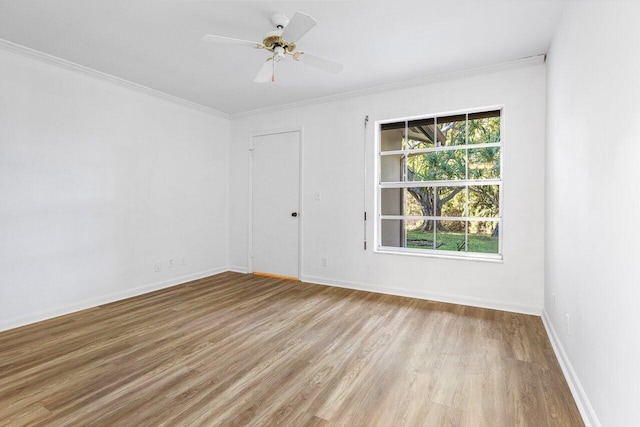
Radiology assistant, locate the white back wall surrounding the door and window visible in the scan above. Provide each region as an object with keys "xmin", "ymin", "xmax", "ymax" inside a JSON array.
[{"xmin": 230, "ymin": 62, "xmax": 545, "ymax": 314}]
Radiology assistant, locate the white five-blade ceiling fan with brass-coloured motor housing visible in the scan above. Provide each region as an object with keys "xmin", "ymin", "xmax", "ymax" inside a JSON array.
[{"xmin": 203, "ymin": 12, "xmax": 342, "ymax": 83}]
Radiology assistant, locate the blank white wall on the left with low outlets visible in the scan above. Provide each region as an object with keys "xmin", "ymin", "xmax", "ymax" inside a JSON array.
[{"xmin": 0, "ymin": 49, "xmax": 229, "ymax": 330}]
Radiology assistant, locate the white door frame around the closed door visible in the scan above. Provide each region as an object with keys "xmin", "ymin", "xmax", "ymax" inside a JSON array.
[{"xmin": 247, "ymin": 126, "xmax": 304, "ymax": 279}]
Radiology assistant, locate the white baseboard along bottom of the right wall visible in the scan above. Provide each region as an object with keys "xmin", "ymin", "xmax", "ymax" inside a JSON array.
[{"xmin": 542, "ymin": 310, "xmax": 601, "ymax": 427}]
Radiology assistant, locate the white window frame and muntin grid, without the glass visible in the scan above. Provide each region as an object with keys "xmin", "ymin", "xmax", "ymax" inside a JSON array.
[{"xmin": 374, "ymin": 105, "xmax": 505, "ymax": 262}]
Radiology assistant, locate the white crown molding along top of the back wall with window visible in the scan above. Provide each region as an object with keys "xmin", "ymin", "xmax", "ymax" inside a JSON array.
[{"xmin": 229, "ymin": 54, "xmax": 546, "ymax": 119}]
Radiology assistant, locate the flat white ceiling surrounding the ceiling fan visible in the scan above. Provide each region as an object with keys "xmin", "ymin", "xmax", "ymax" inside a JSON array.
[{"xmin": 0, "ymin": 0, "xmax": 563, "ymax": 114}]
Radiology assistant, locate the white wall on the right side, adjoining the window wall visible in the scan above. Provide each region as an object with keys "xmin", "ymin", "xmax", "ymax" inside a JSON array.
[{"xmin": 544, "ymin": 1, "xmax": 640, "ymax": 427}]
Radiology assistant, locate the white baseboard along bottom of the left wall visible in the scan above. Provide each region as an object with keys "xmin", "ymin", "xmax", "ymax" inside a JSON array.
[{"xmin": 0, "ymin": 266, "xmax": 229, "ymax": 332}]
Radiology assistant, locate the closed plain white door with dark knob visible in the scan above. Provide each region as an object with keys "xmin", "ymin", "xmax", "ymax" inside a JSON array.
[{"xmin": 250, "ymin": 131, "xmax": 300, "ymax": 278}]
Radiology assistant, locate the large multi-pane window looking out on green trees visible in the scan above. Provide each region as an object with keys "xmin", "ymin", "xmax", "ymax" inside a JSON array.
[{"xmin": 376, "ymin": 109, "xmax": 503, "ymax": 259}]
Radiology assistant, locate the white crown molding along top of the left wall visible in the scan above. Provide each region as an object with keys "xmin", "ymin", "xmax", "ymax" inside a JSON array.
[{"xmin": 0, "ymin": 39, "xmax": 230, "ymax": 119}]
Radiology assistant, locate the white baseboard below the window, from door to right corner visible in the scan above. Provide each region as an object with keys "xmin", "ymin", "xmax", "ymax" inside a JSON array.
[{"xmin": 300, "ymin": 276, "xmax": 542, "ymax": 316}]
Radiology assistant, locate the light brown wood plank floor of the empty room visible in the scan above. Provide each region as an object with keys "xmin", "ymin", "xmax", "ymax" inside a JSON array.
[{"xmin": 0, "ymin": 273, "xmax": 583, "ymax": 427}]
